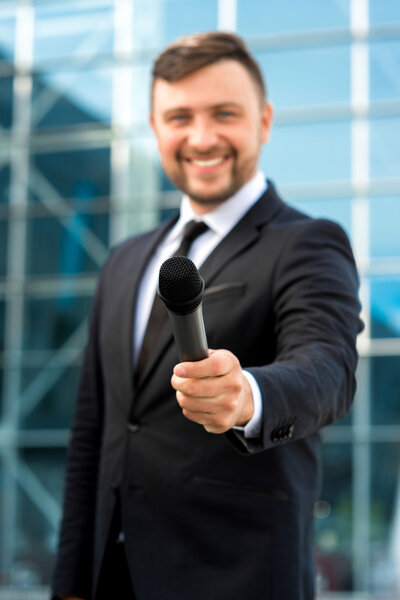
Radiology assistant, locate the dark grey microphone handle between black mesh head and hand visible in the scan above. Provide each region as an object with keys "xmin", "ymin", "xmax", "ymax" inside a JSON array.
[{"xmin": 167, "ymin": 303, "xmax": 208, "ymax": 362}]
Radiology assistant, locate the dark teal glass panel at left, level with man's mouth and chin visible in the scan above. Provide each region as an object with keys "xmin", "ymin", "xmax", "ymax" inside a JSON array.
[{"xmin": 29, "ymin": 148, "xmax": 110, "ymax": 203}]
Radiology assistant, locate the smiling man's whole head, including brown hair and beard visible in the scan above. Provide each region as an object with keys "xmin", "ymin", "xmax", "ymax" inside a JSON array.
[{"xmin": 151, "ymin": 32, "xmax": 272, "ymax": 212}]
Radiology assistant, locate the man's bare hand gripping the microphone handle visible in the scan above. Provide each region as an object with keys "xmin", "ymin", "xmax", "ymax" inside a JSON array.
[{"xmin": 171, "ymin": 350, "xmax": 254, "ymax": 433}]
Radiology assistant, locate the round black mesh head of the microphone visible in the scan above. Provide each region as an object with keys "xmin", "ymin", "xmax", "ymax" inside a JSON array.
[{"xmin": 158, "ymin": 256, "xmax": 204, "ymax": 315}]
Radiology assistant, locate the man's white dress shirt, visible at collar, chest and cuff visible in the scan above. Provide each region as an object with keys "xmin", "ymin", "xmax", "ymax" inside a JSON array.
[{"xmin": 133, "ymin": 171, "xmax": 267, "ymax": 438}]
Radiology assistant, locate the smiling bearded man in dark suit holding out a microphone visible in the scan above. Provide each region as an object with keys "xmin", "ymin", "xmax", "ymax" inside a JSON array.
[{"xmin": 53, "ymin": 33, "xmax": 361, "ymax": 600}]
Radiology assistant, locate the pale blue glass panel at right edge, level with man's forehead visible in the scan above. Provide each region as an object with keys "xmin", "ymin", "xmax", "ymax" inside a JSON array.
[{"xmin": 370, "ymin": 41, "xmax": 400, "ymax": 100}]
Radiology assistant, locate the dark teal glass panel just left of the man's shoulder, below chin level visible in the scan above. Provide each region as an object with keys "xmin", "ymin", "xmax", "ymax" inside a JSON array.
[{"xmin": 26, "ymin": 212, "xmax": 109, "ymax": 275}]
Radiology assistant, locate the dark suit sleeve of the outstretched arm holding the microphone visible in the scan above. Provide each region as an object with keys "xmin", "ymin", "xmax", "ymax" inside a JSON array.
[{"xmin": 229, "ymin": 220, "xmax": 362, "ymax": 452}]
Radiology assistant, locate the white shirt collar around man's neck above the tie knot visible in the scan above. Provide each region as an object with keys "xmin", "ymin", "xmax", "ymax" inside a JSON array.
[{"xmin": 171, "ymin": 171, "xmax": 268, "ymax": 238}]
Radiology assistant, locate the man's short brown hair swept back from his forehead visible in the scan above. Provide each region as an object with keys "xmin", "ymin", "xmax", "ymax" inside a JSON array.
[{"xmin": 151, "ymin": 31, "xmax": 266, "ymax": 101}]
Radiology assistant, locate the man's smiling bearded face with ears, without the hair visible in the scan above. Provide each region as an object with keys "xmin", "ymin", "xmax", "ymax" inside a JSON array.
[{"xmin": 150, "ymin": 60, "xmax": 272, "ymax": 214}]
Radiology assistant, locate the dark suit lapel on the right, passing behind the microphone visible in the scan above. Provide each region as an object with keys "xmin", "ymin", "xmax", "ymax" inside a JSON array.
[{"xmin": 137, "ymin": 182, "xmax": 283, "ymax": 392}]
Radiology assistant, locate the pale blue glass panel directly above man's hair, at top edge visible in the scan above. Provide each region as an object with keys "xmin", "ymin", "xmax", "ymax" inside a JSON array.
[{"xmin": 133, "ymin": 0, "xmax": 218, "ymax": 49}]
